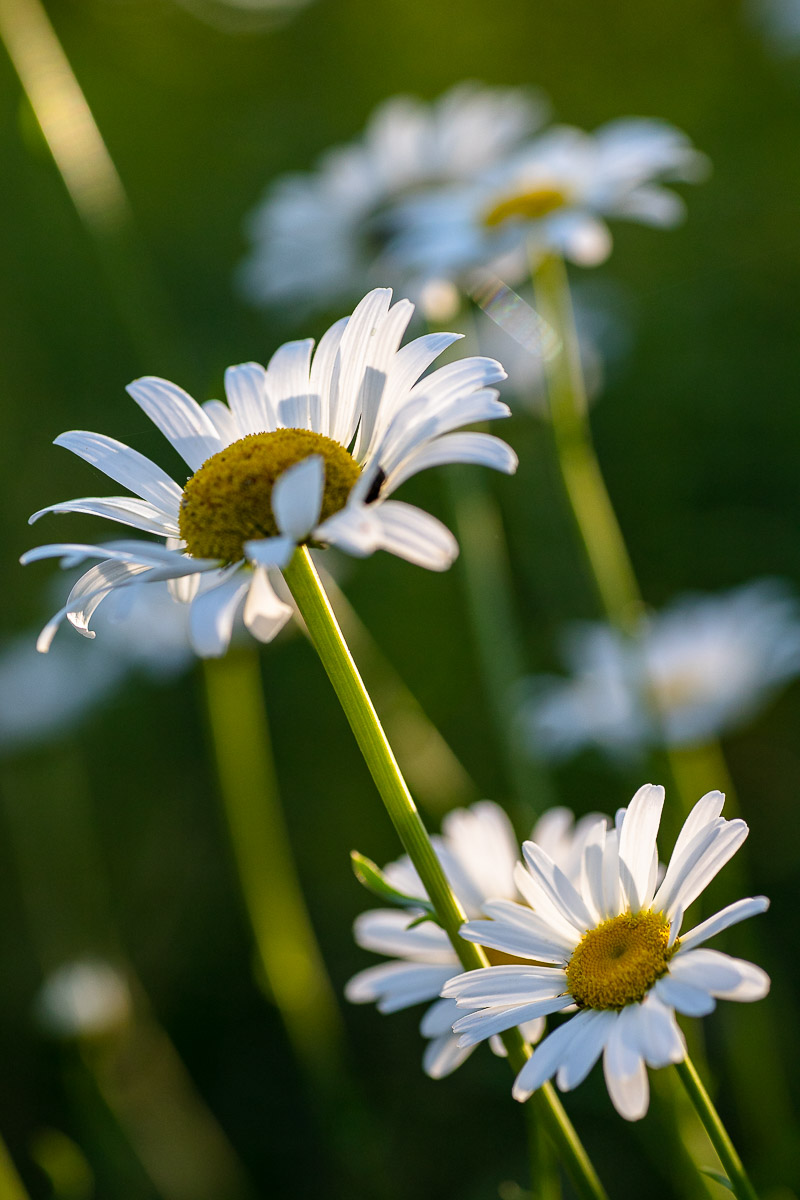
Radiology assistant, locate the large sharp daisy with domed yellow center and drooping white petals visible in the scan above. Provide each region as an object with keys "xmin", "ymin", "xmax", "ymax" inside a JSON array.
[{"xmin": 22, "ymin": 288, "xmax": 517, "ymax": 656}]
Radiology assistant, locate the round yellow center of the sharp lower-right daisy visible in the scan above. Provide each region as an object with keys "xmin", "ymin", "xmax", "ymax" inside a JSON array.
[{"xmin": 566, "ymin": 912, "xmax": 680, "ymax": 1008}]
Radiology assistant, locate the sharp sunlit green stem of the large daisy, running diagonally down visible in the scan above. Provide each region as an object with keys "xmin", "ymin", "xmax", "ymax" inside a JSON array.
[{"xmin": 283, "ymin": 546, "xmax": 606, "ymax": 1200}]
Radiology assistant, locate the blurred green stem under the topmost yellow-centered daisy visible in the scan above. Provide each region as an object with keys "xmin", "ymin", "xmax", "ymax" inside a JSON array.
[{"xmin": 533, "ymin": 254, "xmax": 643, "ymax": 632}]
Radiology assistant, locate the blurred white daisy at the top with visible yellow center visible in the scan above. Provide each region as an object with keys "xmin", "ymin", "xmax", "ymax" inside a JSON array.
[{"xmin": 389, "ymin": 118, "xmax": 708, "ymax": 287}]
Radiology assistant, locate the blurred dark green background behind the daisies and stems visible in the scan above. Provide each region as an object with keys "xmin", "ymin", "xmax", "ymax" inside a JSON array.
[{"xmin": 0, "ymin": 0, "xmax": 800, "ymax": 1200}]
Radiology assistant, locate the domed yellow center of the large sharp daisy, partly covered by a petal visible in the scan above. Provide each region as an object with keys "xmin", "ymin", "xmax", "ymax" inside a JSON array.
[{"xmin": 179, "ymin": 430, "xmax": 361, "ymax": 563}]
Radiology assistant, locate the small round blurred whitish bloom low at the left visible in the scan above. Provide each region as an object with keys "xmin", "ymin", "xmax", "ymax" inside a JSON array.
[{"xmin": 36, "ymin": 959, "xmax": 133, "ymax": 1038}]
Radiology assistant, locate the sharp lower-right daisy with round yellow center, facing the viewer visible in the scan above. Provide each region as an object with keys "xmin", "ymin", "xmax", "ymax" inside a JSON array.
[{"xmin": 443, "ymin": 784, "xmax": 769, "ymax": 1121}]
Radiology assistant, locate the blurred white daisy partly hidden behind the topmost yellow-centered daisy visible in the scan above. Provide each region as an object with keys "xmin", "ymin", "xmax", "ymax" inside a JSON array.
[{"xmin": 241, "ymin": 83, "xmax": 546, "ymax": 312}]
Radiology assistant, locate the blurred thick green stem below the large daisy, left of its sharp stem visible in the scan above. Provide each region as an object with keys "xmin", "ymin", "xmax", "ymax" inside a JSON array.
[{"xmin": 204, "ymin": 648, "xmax": 342, "ymax": 1079}]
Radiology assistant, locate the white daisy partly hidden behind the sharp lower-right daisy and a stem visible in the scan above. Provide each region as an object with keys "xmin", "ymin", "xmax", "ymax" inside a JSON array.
[{"xmin": 345, "ymin": 800, "xmax": 604, "ymax": 1079}]
